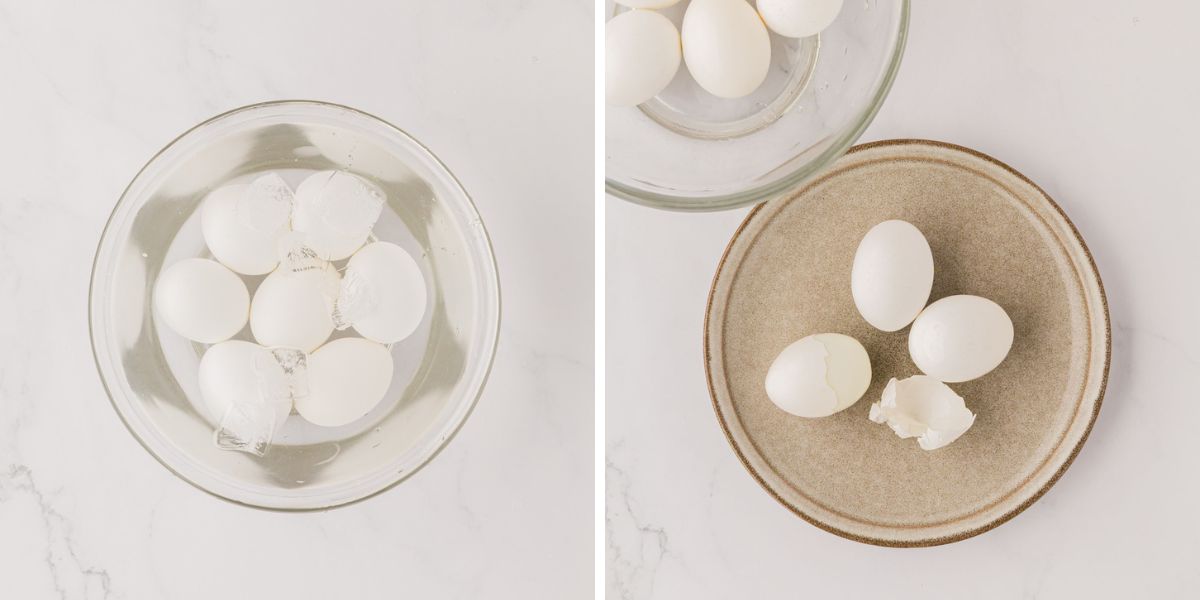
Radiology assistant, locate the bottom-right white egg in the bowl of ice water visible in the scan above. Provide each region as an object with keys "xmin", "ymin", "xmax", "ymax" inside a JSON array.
[{"xmin": 296, "ymin": 337, "xmax": 392, "ymax": 427}]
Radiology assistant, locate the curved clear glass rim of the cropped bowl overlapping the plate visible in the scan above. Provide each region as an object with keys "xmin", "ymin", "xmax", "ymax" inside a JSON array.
[{"xmin": 604, "ymin": 0, "xmax": 911, "ymax": 212}]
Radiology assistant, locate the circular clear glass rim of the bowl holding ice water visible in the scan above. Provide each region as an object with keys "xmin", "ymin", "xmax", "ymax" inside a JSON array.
[{"xmin": 88, "ymin": 100, "xmax": 502, "ymax": 512}]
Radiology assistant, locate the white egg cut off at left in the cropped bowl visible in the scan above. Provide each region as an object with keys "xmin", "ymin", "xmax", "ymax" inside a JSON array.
[{"xmin": 604, "ymin": 11, "xmax": 683, "ymax": 107}]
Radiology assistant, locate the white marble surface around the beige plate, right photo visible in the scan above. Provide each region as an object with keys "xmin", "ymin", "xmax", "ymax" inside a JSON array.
[{"xmin": 606, "ymin": 0, "xmax": 1200, "ymax": 600}]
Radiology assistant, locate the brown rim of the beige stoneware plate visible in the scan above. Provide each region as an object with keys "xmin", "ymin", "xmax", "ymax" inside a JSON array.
[{"xmin": 704, "ymin": 138, "xmax": 1112, "ymax": 548}]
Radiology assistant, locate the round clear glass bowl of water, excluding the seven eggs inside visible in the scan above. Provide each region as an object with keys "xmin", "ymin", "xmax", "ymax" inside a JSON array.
[{"xmin": 89, "ymin": 101, "xmax": 499, "ymax": 510}]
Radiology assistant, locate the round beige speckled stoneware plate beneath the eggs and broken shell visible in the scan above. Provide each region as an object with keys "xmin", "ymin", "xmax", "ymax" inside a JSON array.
[{"xmin": 704, "ymin": 140, "xmax": 1110, "ymax": 546}]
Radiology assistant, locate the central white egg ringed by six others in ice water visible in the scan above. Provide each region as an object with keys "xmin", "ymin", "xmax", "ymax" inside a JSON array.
[{"xmin": 250, "ymin": 263, "xmax": 341, "ymax": 352}]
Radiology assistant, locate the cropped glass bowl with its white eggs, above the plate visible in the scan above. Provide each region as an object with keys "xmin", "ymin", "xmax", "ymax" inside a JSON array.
[{"xmin": 605, "ymin": 0, "xmax": 910, "ymax": 211}]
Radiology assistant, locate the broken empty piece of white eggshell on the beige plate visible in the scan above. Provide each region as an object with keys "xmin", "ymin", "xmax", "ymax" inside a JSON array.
[{"xmin": 870, "ymin": 376, "xmax": 974, "ymax": 450}]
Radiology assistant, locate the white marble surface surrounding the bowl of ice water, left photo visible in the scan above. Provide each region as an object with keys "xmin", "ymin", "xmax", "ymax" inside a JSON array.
[{"xmin": 0, "ymin": 0, "xmax": 594, "ymax": 600}]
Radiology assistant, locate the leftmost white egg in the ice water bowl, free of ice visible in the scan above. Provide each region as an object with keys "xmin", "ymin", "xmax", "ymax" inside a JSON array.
[{"xmin": 154, "ymin": 258, "xmax": 250, "ymax": 343}]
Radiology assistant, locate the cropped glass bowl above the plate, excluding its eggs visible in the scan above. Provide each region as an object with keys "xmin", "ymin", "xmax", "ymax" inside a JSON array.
[{"xmin": 605, "ymin": 0, "xmax": 908, "ymax": 211}]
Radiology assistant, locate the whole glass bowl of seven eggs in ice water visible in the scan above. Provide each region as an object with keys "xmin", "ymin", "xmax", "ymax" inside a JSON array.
[{"xmin": 89, "ymin": 101, "xmax": 499, "ymax": 510}]
